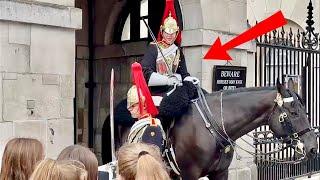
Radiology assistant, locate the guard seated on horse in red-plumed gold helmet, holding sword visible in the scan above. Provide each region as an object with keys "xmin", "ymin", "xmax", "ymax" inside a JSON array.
[{"xmin": 141, "ymin": 0, "xmax": 200, "ymax": 117}]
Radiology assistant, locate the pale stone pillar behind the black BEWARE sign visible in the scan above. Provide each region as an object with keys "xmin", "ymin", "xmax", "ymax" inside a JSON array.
[{"xmin": 180, "ymin": 0, "xmax": 256, "ymax": 180}]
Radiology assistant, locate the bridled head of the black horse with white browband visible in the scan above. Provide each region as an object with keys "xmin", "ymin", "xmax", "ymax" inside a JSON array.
[{"xmin": 269, "ymin": 80, "xmax": 318, "ymax": 158}]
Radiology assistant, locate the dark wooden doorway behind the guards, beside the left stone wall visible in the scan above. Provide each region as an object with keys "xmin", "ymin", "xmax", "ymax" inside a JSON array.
[{"xmin": 75, "ymin": 0, "xmax": 171, "ymax": 163}]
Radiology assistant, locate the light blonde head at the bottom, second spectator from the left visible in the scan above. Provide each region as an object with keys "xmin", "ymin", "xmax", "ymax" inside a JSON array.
[{"xmin": 30, "ymin": 159, "xmax": 88, "ymax": 180}]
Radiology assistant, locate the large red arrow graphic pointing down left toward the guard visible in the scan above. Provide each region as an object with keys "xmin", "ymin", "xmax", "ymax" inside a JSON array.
[{"xmin": 204, "ymin": 11, "xmax": 287, "ymax": 60}]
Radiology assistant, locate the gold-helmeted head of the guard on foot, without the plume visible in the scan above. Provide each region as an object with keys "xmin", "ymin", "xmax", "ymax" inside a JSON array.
[{"xmin": 127, "ymin": 85, "xmax": 147, "ymax": 118}]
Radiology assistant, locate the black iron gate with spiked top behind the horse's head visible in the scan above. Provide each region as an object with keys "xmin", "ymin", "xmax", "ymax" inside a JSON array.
[{"xmin": 254, "ymin": 2, "xmax": 320, "ymax": 180}]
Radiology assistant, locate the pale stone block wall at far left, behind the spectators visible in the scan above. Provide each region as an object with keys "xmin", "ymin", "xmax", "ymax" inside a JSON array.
[{"xmin": 0, "ymin": 0, "xmax": 82, "ymax": 158}]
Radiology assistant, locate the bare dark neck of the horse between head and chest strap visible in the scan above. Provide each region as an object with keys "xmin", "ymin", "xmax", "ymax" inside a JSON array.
[{"xmin": 223, "ymin": 89, "xmax": 276, "ymax": 140}]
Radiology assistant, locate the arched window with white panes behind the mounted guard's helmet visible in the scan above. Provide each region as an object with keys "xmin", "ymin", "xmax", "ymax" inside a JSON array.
[{"xmin": 113, "ymin": 0, "xmax": 170, "ymax": 43}]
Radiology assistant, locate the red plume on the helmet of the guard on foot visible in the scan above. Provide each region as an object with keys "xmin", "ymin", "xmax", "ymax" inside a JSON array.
[{"xmin": 131, "ymin": 62, "xmax": 158, "ymax": 117}]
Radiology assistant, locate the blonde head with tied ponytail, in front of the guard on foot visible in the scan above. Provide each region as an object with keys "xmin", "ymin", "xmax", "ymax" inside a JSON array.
[{"xmin": 118, "ymin": 143, "xmax": 170, "ymax": 180}]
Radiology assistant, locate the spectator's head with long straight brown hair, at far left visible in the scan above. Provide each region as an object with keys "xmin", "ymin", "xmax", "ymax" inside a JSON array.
[{"xmin": 0, "ymin": 138, "xmax": 44, "ymax": 180}]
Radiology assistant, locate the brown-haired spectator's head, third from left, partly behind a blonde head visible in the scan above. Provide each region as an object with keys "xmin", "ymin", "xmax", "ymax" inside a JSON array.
[{"xmin": 58, "ymin": 145, "xmax": 98, "ymax": 180}]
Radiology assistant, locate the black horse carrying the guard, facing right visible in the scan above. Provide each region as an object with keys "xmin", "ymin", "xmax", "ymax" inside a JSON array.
[{"xmin": 102, "ymin": 82, "xmax": 318, "ymax": 180}]
